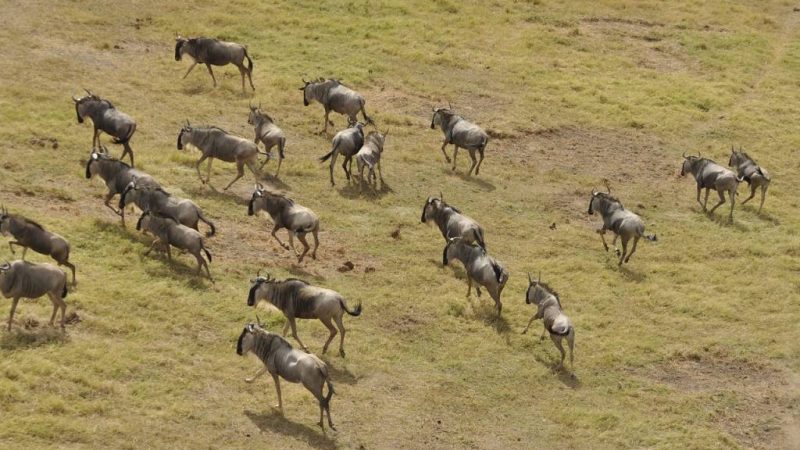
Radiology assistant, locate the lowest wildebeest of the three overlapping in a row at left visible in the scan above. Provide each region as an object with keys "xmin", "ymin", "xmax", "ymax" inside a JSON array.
[{"xmin": 136, "ymin": 211, "xmax": 212, "ymax": 280}]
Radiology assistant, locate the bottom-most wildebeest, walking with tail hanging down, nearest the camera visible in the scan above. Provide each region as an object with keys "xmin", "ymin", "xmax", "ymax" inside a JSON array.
[{"xmin": 236, "ymin": 323, "xmax": 336, "ymax": 430}]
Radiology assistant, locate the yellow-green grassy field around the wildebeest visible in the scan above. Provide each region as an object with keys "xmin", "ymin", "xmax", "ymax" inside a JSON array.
[{"xmin": 0, "ymin": 0, "xmax": 800, "ymax": 448}]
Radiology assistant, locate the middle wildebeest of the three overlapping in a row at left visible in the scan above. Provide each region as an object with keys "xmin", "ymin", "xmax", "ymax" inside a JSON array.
[{"xmin": 119, "ymin": 179, "xmax": 216, "ymax": 237}]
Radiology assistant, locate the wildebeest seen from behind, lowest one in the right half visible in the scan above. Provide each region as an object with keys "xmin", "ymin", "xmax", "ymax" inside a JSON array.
[{"xmin": 522, "ymin": 273, "xmax": 575, "ymax": 367}]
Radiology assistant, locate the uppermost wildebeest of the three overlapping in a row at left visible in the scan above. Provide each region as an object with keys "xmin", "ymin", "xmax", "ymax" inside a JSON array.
[{"xmin": 86, "ymin": 148, "xmax": 160, "ymax": 226}]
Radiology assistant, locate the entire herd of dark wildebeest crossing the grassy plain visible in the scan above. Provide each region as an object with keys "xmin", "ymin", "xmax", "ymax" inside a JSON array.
[{"xmin": 0, "ymin": 36, "xmax": 771, "ymax": 429}]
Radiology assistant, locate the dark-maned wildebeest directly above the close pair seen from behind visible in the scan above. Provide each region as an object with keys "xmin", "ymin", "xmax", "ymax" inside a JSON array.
[{"xmin": 300, "ymin": 78, "xmax": 373, "ymax": 133}]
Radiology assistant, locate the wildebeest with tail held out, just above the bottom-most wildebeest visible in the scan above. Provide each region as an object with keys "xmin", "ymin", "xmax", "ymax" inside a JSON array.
[{"xmin": 247, "ymin": 274, "xmax": 361, "ymax": 357}]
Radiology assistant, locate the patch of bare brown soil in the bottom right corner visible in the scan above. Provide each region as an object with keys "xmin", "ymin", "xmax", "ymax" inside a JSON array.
[{"xmin": 645, "ymin": 356, "xmax": 800, "ymax": 448}]
